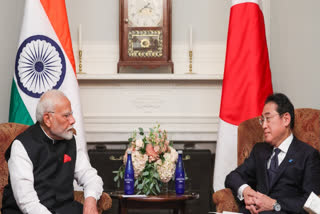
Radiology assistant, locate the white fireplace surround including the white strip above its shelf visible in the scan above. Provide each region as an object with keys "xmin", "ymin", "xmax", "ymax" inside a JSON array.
[{"xmin": 75, "ymin": 42, "xmax": 225, "ymax": 143}]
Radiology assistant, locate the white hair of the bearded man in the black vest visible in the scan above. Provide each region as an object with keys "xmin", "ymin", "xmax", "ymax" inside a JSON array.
[{"xmin": 36, "ymin": 89, "xmax": 66, "ymax": 123}]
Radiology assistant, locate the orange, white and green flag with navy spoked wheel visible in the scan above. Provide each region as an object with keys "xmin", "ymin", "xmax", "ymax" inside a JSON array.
[{"xmin": 9, "ymin": 0, "xmax": 86, "ymax": 149}]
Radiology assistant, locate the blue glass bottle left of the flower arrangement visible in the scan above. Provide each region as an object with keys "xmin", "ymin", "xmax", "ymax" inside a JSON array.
[{"xmin": 124, "ymin": 151, "xmax": 134, "ymax": 195}]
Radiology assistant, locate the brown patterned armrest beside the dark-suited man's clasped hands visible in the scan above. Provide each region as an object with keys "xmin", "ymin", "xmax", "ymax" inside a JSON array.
[{"xmin": 212, "ymin": 188, "xmax": 239, "ymax": 213}]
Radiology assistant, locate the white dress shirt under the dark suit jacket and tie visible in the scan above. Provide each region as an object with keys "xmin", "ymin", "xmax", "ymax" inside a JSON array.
[{"xmin": 238, "ymin": 133, "xmax": 293, "ymax": 201}]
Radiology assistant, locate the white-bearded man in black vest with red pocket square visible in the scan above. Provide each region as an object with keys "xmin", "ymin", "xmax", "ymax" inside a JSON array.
[{"xmin": 1, "ymin": 90, "xmax": 103, "ymax": 214}]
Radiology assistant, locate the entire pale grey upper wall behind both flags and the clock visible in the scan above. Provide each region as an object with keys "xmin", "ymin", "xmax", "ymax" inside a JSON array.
[{"xmin": 0, "ymin": 0, "xmax": 320, "ymax": 122}]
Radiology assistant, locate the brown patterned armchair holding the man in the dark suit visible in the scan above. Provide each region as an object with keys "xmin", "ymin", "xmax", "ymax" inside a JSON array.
[{"xmin": 212, "ymin": 108, "xmax": 320, "ymax": 212}]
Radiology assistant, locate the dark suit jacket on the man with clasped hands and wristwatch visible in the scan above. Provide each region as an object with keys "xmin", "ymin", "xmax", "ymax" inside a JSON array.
[{"xmin": 225, "ymin": 137, "xmax": 320, "ymax": 213}]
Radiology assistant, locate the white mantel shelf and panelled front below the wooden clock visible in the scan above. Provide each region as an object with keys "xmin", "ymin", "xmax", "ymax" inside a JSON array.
[{"xmin": 79, "ymin": 75, "xmax": 222, "ymax": 142}]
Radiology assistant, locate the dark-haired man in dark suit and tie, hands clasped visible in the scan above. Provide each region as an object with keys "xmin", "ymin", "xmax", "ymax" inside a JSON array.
[{"xmin": 225, "ymin": 93, "xmax": 320, "ymax": 214}]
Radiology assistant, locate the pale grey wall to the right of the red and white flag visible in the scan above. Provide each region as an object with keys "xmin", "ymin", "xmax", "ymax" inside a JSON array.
[{"xmin": 270, "ymin": 0, "xmax": 320, "ymax": 109}]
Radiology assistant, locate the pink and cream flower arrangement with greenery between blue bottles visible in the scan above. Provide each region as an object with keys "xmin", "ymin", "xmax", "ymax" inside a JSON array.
[{"xmin": 113, "ymin": 125, "xmax": 178, "ymax": 195}]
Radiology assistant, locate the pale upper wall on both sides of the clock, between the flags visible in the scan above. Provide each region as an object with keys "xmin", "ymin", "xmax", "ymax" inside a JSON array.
[{"xmin": 66, "ymin": 0, "xmax": 229, "ymax": 43}]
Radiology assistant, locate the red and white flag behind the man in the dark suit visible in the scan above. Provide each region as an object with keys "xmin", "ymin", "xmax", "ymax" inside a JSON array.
[{"xmin": 214, "ymin": 0, "xmax": 272, "ymax": 191}]
